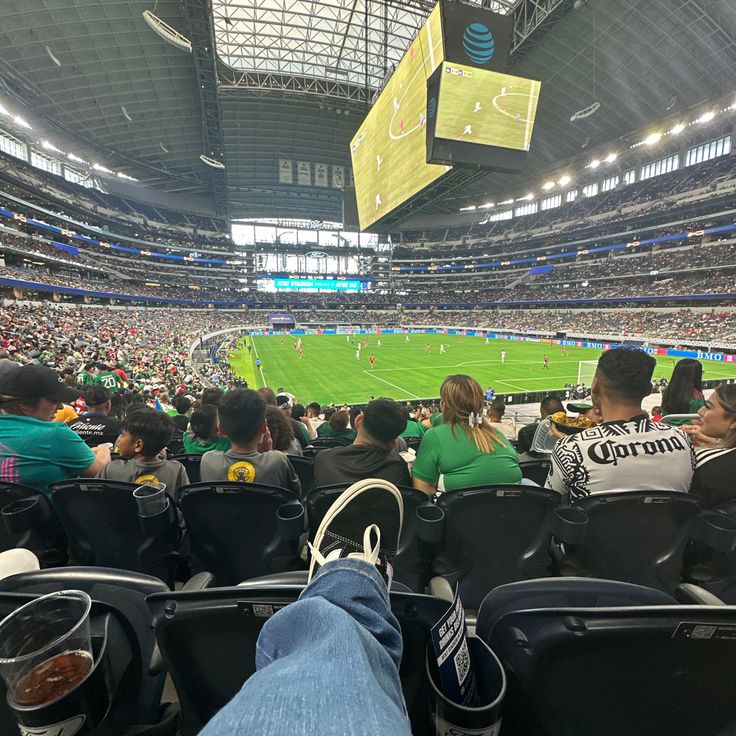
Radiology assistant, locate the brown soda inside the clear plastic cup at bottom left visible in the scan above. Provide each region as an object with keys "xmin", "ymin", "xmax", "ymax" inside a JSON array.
[{"xmin": 13, "ymin": 649, "xmax": 94, "ymax": 706}]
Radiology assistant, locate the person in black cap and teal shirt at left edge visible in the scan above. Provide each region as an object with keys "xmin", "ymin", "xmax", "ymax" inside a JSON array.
[{"xmin": 0, "ymin": 365, "xmax": 110, "ymax": 492}]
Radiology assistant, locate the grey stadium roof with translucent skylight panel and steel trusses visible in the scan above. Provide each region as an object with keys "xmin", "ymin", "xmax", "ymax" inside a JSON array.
[{"xmin": 0, "ymin": 0, "xmax": 736, "ymax": 224}]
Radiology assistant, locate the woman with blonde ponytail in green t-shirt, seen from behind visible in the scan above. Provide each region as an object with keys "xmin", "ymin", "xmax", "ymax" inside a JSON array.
[{"xmin": 412, "ymin": 374, "xmax": 521, "ymax": 498}]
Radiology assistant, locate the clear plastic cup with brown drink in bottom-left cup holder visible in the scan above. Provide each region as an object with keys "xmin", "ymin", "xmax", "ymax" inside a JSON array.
[{"xmin": 0, "ymin": 590, "xmax": 94, "ymax": 706}]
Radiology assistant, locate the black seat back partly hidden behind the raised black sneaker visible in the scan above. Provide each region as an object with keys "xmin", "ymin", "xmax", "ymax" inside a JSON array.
[{"xmin": 307, "ymin": 483, "xmax": 430, "ymax": 592}]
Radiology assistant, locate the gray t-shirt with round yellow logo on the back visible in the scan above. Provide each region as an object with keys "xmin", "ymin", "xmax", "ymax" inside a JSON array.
[{"xmin": 199, "ymin": 450, "xmax": 301, "ymax": 495}]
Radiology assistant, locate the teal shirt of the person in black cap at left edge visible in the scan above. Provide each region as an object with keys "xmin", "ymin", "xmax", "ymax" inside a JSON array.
[{"xmin": 0, "ymin": 414, "xmax": 95, "ymax": 495}]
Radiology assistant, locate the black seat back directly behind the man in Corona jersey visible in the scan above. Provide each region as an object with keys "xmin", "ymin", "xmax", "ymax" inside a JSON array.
[{"xmin": 561, "ymin": 491, "xmax": 699, "ymax": 593}]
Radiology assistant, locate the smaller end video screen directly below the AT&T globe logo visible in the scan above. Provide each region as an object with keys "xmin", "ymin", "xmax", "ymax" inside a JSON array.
[{"xmin": 434, "ymin": 62, "xmax": 541, "ymax": 151}]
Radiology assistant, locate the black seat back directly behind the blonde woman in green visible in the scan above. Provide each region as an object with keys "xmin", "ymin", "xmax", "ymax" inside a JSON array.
[{"xmin": 433, "ymin": 485, "xmax": 560, "ymax": 608}]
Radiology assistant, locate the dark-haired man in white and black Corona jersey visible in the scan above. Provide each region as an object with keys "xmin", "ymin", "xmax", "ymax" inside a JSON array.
[{"xmin": 546, "ymin": 348, "xmax": 695, "ymax": 501}]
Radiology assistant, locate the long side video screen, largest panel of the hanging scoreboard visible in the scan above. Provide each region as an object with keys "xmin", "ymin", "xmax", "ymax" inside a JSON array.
[{"xmin": 350, "ymin": 5, "xmax": 447, "ymax": 230}]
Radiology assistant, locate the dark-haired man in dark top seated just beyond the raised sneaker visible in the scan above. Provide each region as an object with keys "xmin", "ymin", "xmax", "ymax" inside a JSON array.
[{"xmin": 314, "ymin": 399, "xmax": 411, "ymax": 488}]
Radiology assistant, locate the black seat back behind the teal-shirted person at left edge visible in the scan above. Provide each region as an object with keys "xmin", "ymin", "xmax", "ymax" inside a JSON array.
[{"xmin": 0, "ymin": 483, "xmax": 67, "ymax": 565}]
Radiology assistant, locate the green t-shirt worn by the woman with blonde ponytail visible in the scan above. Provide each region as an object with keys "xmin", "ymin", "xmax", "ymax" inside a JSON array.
[{"xmin": 412, "ymin": 424, "xmax": 521, "ymax": 491}]
